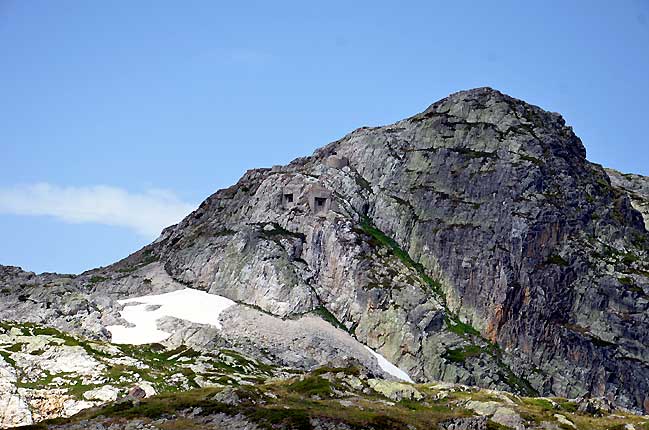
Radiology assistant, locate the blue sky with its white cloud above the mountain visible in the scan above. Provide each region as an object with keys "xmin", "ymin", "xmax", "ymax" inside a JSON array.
[{"xmin": 0, "ymin": 0, "xmax": 649, "ymax": 273}]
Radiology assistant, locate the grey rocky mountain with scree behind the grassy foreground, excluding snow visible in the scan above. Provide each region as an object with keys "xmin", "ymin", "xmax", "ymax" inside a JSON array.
[{"xmin": 0, "ymin": 88, "xmax": 649, "ymax": 428}]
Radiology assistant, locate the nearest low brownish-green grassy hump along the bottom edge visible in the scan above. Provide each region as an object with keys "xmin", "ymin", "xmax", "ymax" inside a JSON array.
[{"xmin": 11, "ymin": 358, "xmax": 649, "ymax": 430}]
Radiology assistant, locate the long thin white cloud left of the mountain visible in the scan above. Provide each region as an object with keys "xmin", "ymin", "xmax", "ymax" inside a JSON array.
[{"xmin": 0, "ymin": 183, "xmax": 194, "ymax": 238}]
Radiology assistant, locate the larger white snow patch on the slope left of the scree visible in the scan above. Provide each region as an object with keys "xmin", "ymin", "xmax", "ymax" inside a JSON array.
[{"xmin": 106, "ymin": 288, "xmax": 236, "ymax": 345}]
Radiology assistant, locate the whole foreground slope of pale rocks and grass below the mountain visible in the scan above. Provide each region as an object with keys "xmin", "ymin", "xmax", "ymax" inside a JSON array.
[{"xmin": 0, "ymin": 323, "xmax": 649, "ymax": 430}]
